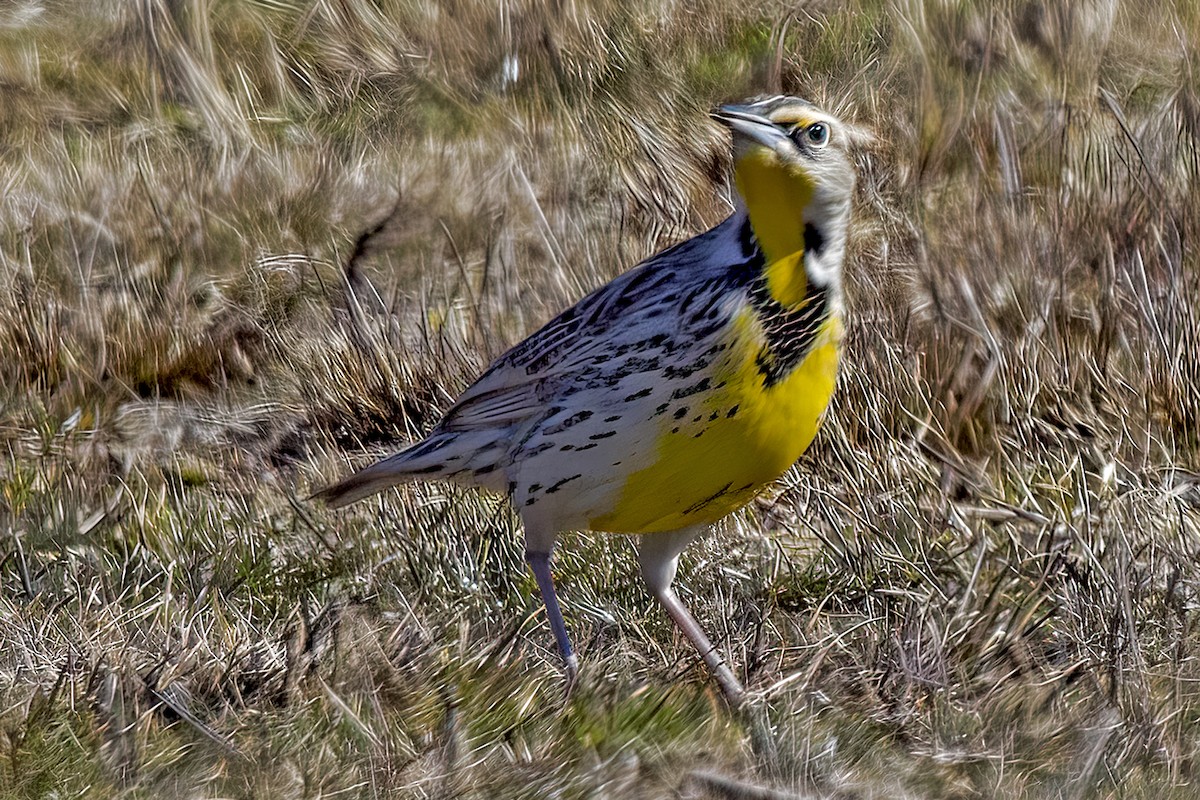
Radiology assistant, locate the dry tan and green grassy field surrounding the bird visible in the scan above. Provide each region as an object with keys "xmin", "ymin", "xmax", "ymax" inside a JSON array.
[{"xmin": 0, "ymin": 0, "xmax": 1200, "ymax": 800}]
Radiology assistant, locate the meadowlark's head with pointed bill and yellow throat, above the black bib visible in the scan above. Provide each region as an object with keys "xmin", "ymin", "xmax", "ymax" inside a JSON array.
[{"xmin": 713, "ymin": 97, "xmax": 854, "ymax": 279}]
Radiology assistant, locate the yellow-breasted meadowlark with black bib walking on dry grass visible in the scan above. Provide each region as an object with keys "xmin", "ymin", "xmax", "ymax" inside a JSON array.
[{"xmin": 316, "ymin": 97, "xmax": 854, "ymax": 703}]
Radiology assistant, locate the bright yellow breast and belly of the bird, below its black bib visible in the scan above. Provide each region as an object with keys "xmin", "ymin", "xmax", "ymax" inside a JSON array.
[{"xmin": 589, "ymin": 309, "xmax": 841, "ymax": 534}]
